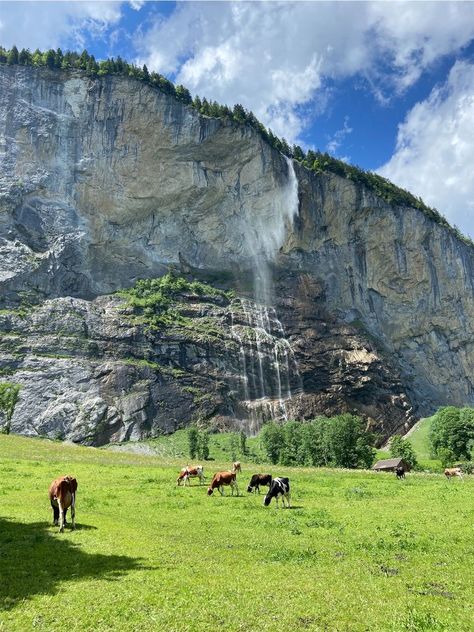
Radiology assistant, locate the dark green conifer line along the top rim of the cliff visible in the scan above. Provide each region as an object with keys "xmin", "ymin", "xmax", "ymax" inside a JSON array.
[{"xmin": 0, "ymin": 46, "xmax": 474, "ymax": 245}]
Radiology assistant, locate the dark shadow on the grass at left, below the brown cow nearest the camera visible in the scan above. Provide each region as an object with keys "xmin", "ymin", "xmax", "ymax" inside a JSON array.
[{"xmin": 0, "ymin": 518, "xmax": 145, "ymax": 611}]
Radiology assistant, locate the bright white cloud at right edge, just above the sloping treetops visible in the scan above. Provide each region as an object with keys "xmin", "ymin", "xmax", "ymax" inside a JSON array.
[{"xmin": 378, "ymin": 62, "xmax": 474, "ymax": 237}]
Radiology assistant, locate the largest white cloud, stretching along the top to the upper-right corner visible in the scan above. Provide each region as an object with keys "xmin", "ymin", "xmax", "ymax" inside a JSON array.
[{"xmin": 139, "ymin": 2, "xmax": 474, "ymax": 141}]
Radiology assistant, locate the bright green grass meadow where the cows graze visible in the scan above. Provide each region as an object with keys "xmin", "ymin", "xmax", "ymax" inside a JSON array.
[{"xmin": 0, "ymin": 435, "xmax": 474, "ymax": 632}]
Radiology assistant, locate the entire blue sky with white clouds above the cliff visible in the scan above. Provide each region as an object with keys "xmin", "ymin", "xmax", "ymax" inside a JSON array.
[{"xmin": 0, "ymin": 0, "xmax": 474, "ymax": 237}]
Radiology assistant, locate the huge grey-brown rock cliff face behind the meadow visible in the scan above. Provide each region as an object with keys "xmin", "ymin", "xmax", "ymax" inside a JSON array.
[{"xmin": 0, "ymin": 66, "xmax": 474, "ymax": 444}]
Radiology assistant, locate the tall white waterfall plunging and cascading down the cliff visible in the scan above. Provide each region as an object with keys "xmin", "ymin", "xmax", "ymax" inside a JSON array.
[{"xmin": 231, "ymin": 158, "xmax": 300, "ymax": 434}]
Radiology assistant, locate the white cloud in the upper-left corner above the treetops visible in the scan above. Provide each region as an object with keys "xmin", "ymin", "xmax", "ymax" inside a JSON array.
[{"xmin": 0, "ymin": 1, "xmax": 122, "ymax": 50}]
